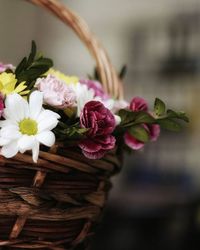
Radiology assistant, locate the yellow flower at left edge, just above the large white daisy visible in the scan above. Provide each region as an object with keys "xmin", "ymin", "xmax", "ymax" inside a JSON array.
[{"xmin": 0, "ymin": 72, "xmax": 29, "ymax": 95}]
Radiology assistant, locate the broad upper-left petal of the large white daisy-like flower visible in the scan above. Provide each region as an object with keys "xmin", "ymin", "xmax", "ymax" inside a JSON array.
[{"xmin": 4, "ymin": 94, "xmax": 29, "ymax": 121}]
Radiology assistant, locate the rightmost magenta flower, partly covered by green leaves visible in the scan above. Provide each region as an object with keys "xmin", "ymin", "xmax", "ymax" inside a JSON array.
[{"xmin": 124, "ymin": 97, "xmax": 160, "ymax": 150}]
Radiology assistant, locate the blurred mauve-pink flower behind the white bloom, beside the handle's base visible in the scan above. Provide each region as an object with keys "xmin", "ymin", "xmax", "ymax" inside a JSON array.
[{"xmin": 80, "ymin": 79, "xmax": 109, "ymax": 100}]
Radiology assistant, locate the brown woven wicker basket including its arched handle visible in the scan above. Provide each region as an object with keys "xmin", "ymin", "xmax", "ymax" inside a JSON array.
[{"xmin": 0, "ymin": 0, "xmax": 123, "ymax": 250}]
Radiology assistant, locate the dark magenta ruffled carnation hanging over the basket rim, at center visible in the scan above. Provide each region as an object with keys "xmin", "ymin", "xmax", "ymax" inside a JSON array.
[{"xmin": 79, "ymin": 101, "xmax": 115, "ymax": 159}]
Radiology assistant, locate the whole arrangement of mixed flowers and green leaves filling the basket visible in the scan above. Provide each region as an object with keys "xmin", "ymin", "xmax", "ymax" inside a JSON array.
[{"xmin": 0, "ymin": 42, "xmax": 188, "ymax": 163}]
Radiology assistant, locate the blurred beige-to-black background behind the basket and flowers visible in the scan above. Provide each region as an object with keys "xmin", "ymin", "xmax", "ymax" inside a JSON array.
[{"xmin": 0, "ymin": 0, "xmax": 200, "ymax": 250}]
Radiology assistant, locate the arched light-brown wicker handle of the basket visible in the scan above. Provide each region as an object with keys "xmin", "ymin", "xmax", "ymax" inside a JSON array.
[{"xmin": 26, "ymin": 0, "xmax": 123, "ymax": 99}]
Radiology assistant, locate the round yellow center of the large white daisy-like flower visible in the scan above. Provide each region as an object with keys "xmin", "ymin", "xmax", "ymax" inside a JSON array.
[{"xmin": 19, "ymin": 118, "xmax": 38, "ymax": 135}]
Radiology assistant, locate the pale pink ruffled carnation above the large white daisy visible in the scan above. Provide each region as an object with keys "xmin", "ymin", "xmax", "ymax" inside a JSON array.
[{"xmin": 36, "ymin": 75, "xmax": 76, "ymax": 109}]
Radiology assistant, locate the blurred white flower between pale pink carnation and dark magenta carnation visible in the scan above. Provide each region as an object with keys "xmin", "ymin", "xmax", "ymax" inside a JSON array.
[{"xmin": 70, "ymin": 82, "xmax": 100, "ymax": 117}]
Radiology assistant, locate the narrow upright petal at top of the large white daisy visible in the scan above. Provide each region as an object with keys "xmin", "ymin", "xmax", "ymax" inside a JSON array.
[{"xmin": 29, "ymin": 91, "xmax": 43, "ymax": 119}]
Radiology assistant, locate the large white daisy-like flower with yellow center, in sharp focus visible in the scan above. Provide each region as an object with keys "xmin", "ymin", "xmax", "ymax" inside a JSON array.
[{"xmin": 0, "ymin": 91, "xmax": 60, "ymax": 162}]
